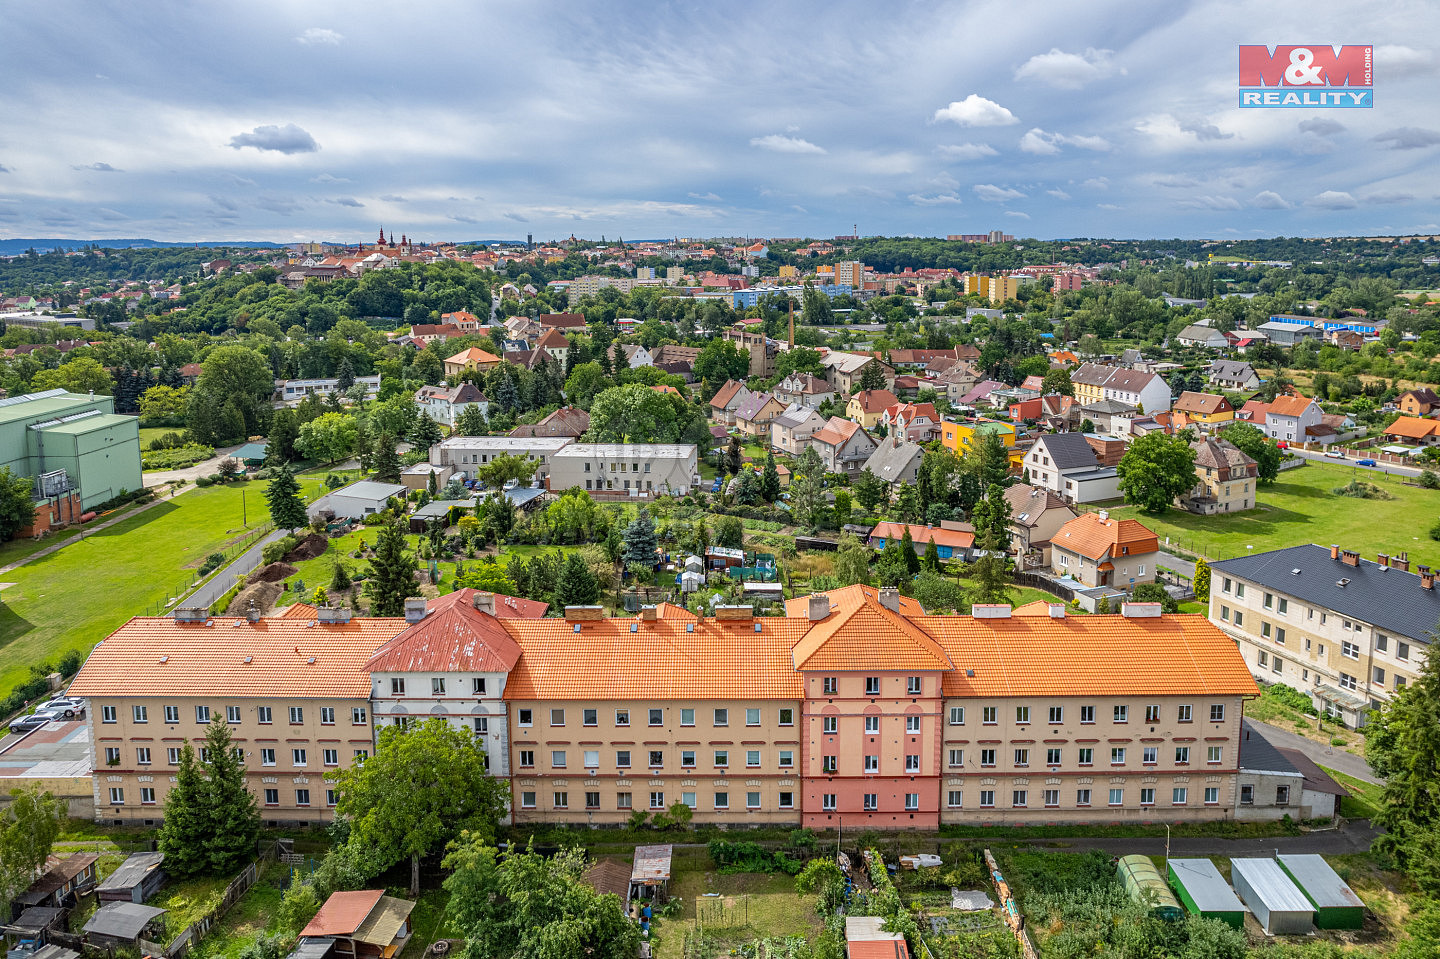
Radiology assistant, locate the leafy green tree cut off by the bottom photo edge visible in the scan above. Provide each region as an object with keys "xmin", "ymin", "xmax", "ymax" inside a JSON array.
[{"xmin": 444, "ymin": 834, "xmax": 639, "ymax": 959}]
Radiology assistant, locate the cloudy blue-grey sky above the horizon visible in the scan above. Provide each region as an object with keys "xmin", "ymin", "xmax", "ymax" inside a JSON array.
[{"xmin": 0, "ymin": 0, "xmax": 1440, "ymax": 242}]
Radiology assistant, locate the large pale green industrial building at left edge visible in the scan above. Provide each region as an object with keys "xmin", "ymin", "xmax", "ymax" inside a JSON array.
[{"xmin": 0, "ymin": 390, "xmax": 144, "ymax": 512}]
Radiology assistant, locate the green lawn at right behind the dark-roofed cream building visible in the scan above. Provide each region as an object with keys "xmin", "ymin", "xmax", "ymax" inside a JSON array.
[{"xmin": 1110, "ymin": 462, "xmax": 1440, "ymax": 569}]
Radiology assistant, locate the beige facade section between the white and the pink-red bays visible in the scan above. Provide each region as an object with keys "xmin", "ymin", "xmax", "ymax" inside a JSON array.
[{"xmin": 507, "ymin": 697, "xmax": 801, "ymax": 825}]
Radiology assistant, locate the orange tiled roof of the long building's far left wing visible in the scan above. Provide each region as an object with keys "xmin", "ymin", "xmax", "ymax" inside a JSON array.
[{"xmin": 71, "ymin": 616, "xmax": 406, "ymax": 698}]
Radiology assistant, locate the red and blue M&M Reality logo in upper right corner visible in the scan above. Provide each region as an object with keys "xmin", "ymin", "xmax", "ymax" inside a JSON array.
[{"xmin": 1240, "ymin": 43, "xmax": 1375, "ymax": 109}]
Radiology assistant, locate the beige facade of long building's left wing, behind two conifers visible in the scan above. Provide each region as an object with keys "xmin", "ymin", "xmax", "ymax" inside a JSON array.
[{"xmin": 89, "ymin": 694, "xmax": 374, "ymax": 824}]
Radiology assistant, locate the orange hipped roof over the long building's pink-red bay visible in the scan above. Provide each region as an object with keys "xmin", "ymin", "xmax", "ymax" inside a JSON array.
[{"xmin": 791, "ymin": 586, "xmax": 955, "ymax": 671}]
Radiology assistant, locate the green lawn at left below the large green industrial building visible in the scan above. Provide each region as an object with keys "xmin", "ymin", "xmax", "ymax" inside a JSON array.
[{"xmin": 0, "ymin": 482, "xmax": 280, "ymax": 691}]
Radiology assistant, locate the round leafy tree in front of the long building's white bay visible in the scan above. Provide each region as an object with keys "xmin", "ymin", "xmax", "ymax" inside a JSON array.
[{"xmin": 327, "ymin": 717, "xmax": 507, "ymax": 897}]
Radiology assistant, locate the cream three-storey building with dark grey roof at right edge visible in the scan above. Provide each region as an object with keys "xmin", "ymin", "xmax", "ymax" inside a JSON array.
[{"xmin": 1210, "ymin": 544, "xmax": 1440, "ymax": 727}]
